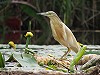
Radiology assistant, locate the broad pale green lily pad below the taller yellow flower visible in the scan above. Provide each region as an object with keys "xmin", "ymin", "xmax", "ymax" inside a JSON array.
[{"xmin": 13, "ymin": 53, "xmax": 39, "ymax": 67}]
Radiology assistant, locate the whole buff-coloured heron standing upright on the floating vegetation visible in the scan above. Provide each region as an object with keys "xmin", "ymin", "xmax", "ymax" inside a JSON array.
[{"xmin": 39, "ymin": 11, "xmax": 80, "ymax": 59}]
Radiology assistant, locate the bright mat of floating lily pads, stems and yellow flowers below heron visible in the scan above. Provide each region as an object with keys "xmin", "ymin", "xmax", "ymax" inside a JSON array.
[{"xmin": 0, "ymin": 32, "xmax": 100, "ymax": 74}]
